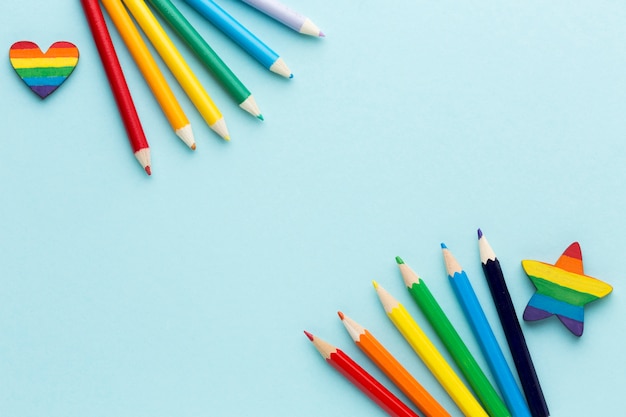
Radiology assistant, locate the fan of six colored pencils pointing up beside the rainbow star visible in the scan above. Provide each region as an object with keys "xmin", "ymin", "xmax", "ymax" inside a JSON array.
[{"xmin": 305, "ymin": 230, "xmax": 572, "ymax": 417}]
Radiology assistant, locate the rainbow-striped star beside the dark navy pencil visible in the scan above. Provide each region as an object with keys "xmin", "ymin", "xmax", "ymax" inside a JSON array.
[{"xmin": 522, "ymin": 242, "xmax": 613, "ymax": 336}]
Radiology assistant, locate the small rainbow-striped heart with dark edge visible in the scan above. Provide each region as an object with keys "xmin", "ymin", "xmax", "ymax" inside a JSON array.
[{"xmin": 9, "ymin": 41, "xmax": 78, "ymax": 98}]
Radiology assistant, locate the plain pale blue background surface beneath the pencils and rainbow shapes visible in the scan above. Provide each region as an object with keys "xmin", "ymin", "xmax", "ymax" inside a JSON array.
[{"xmin": 0, "ymin": 0, "xmax": 626, "ymax": 417}]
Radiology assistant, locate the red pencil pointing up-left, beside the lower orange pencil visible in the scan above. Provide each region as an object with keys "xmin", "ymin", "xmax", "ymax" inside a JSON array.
[{"xmin": 304, "ymin": 331, "xmax": 417, "ymax": 417}]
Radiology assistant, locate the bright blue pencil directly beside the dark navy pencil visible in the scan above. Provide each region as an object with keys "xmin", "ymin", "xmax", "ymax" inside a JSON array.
[{"xmin": 441, "ymin": 243, "xmax": 530, "ymax": 417}]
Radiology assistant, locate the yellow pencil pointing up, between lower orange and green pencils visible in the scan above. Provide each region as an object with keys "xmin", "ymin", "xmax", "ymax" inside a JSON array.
[{"xmin": 374, "ymin": 282, "xmax": 487, "ymax": 417}]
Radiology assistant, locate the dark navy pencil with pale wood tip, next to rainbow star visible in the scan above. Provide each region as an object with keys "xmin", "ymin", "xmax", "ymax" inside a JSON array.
[{"xmin": 478, "ymin": 229, "xmax": 550, "ymax": 417}]
